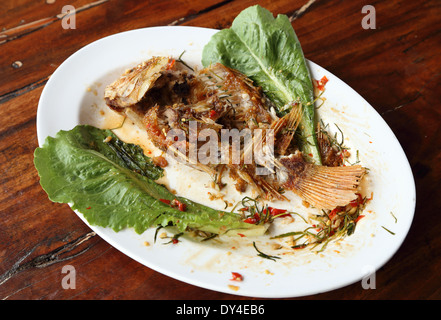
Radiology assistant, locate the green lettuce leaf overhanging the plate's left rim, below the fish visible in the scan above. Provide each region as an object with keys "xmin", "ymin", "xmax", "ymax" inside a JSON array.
[{"xmin": 34, "ymin": 125, "xmax": 265, "ymax": 235}]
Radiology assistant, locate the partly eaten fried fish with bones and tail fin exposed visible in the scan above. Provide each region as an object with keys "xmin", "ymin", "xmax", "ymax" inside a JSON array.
[{"xmin": 104, "ymin": 57, "xmax": 366, "ymax": 210}]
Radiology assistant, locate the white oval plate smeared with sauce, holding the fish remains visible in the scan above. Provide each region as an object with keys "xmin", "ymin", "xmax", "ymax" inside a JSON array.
[{"xmin": 37, "ymin": 27, "xmax": 415, "ymax": 298}]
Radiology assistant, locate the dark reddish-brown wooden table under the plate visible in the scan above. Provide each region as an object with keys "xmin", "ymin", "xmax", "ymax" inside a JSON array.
[{"xmin": 0, "ymin": 0, "xmax": 441, "ymax": 300}]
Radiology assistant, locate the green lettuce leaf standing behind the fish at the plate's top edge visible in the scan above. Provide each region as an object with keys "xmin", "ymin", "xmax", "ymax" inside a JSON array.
[{"xmin": 202, "ymin": 5, "xmax": 321, "ymax": 164}]
